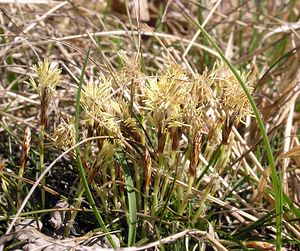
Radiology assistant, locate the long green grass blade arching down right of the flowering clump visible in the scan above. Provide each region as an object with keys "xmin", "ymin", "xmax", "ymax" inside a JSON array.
[{"xmin": 181, "ymin": 13, "xmax": 283, "ymax": 251}]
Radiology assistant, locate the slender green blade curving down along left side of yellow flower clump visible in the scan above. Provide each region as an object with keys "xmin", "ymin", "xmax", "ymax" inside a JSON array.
[{"xmin": 75, "ymin": 50, "xmax": 117, "ymax": 248}]
